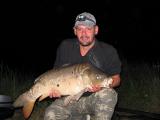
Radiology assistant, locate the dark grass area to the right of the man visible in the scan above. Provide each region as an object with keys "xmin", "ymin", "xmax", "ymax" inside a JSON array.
[{"xmin": 118, "ymin": 61, "xmax": 160, "ymax": 113}]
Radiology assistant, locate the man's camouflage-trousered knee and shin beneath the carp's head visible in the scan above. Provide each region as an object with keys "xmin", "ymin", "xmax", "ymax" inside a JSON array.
[{"xmin": 94, "ymin": 89, "xmax": 117, "ymax": 120}]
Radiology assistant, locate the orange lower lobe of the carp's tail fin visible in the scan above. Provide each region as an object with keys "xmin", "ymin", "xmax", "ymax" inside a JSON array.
[{"xmin": 22, "ymin": 101, "xmax": 35, "ymax": 119}]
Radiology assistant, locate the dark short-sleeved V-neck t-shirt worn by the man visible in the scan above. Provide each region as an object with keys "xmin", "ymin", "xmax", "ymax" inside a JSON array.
[{"xmin": 54, "ymin": 38, "xmax": 121, "ymax": 75}]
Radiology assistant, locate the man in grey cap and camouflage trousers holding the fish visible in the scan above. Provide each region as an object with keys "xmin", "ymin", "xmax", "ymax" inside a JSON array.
[{"xmin": 44, "ymin": 12, "xmax": 121, "ymax": 120}]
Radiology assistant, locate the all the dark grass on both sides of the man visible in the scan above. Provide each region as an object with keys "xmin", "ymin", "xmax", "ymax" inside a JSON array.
[{"xmin": 0, "ymin": 60, "xmax": 160, "ymax": 120}]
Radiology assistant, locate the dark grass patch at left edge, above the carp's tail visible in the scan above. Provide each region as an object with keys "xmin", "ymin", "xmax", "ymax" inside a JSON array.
[{"xmin": 0, "ymin": 63, "xmax": 34, "ymax": 99}]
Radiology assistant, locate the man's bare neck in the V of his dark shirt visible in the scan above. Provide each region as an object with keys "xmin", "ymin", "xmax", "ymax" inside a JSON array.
[{"xmin": 80, "ymin": 41, "xmax": 95, "ymax": 56}]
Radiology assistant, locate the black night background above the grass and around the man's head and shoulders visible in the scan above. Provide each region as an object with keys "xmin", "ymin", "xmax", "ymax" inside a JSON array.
[{"xmin": 0, "ymin": 0, "xmax": 160, "ymax": 73}]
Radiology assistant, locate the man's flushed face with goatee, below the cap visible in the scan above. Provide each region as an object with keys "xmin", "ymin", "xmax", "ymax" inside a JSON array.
[{"xmin": 74, "ymin": 25, "xmax": 98, "ymax": 46}]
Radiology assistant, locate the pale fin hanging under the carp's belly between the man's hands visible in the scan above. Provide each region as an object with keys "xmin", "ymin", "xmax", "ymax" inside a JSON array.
[{"xmin": 64, "ymin": 89, "xmax": 86, "ymax": 106}]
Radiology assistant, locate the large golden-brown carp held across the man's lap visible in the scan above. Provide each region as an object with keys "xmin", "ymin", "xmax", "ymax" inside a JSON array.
[{"xmin": 13, "ymin": 63, "xmax": 112, "ymax": 119}]
